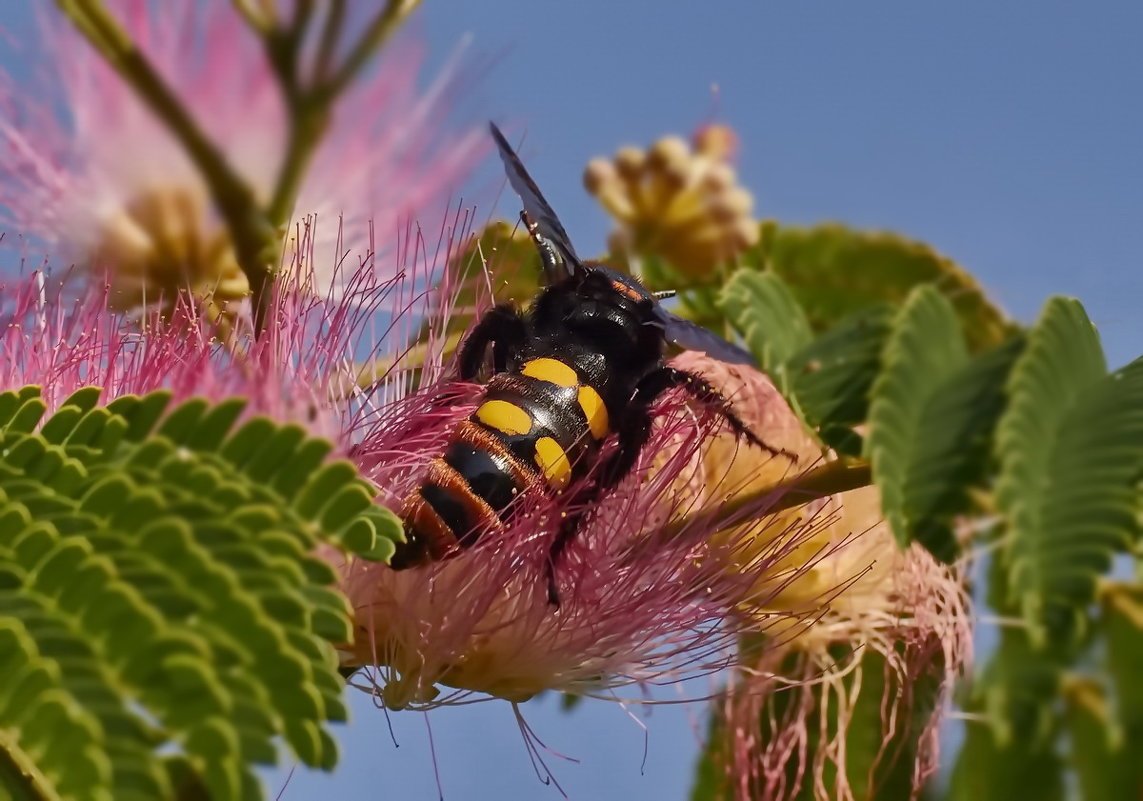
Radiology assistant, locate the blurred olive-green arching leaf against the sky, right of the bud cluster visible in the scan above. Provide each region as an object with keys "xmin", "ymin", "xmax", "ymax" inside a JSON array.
[{"xmin": 744, "ymin": 222, "xmax": 1015, "ymax": 351}]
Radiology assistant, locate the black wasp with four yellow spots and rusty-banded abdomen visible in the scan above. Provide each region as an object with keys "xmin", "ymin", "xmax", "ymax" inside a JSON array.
[{"xmin": 391, "ymin": 123, "xmax": 797, "ymax": 606}]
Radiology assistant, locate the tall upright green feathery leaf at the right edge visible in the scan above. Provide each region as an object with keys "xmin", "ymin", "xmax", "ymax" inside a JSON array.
[{"xmin": 996, "ymin": 298, "xmax": 1143, "ymax": 644}]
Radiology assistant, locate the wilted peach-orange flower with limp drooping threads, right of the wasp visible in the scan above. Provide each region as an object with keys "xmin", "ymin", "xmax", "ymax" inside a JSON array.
[{"xmin": 667, "ymin": 359, "xmax": 972, "ymax": 801}]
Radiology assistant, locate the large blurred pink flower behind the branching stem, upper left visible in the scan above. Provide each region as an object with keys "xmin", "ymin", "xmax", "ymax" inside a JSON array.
[{"xmin": 0, "ymin": 0, "xmax": 483, "ymax": 313}]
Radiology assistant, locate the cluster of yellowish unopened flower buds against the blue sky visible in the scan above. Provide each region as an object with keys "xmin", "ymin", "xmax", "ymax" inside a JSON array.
[{"xmin": 584, "ymin": 125, "xmax": 759, "ymax": 278}]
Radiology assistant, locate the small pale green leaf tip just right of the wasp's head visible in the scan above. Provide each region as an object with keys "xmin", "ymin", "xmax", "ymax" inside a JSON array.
[{"xmin": 719, "ymin": 270, "xmax": 813, "ymax": 374}]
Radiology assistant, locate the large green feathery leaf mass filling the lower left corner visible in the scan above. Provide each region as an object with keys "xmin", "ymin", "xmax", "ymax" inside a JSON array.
[{"xmin": 0, "ymin": 387, "xmax": 401, "ymax": 801}]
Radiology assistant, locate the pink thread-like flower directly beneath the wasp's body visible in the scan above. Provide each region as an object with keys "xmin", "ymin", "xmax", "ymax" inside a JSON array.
[{"xmin": 341, "ymin": 347, "xmax": 836, "ymax": 708}]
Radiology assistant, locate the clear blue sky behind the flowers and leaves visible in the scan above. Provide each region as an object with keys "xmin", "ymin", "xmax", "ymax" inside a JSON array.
[{"xmin": 0, "ymin": 0, "xmax": 1143, "ymax": 801}]
